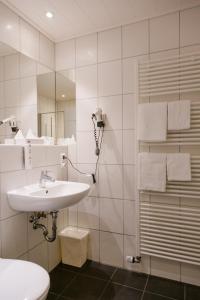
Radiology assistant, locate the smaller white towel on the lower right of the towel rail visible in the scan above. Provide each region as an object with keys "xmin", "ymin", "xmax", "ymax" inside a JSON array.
[{"xmin": 167, "ymin": 153, "xmax": 191, "ymax": 181}]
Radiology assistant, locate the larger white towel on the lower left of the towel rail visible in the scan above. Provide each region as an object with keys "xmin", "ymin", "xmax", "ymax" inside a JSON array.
[{"xmin": 138, "ymin": 153, "xmax": 166, "ymax": 192}]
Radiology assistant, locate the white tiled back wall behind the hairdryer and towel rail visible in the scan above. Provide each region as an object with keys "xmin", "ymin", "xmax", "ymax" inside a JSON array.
[{"xmin": 56, "ymin": 7, "xmax": 200, "ymax": 284}]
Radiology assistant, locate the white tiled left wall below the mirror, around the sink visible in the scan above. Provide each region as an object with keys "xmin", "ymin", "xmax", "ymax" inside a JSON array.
[{"xmin": 0, "ymin": 145, "xmax": 68, "ymax": 270}]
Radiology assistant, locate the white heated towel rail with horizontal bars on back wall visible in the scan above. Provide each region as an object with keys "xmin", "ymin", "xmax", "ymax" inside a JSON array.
[{"xmin": 135, "ymin": 53, "xmax": 200, "ymax": 265}]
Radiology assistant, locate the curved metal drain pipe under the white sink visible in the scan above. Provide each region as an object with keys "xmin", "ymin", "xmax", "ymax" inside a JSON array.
[{"xmin": 29, "ymin": 211, "xmax": 58, "ymax": 243}]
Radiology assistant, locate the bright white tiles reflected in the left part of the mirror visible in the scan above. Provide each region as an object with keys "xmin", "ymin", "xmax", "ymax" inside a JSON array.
[{"xmin": 0, "ymin": 42, "xmax": 37, "ymax": 143}]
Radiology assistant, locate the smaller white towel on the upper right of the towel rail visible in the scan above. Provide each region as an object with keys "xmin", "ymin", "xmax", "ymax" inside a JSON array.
[{"xmin": 168, "ymin": 100, "xmax": 190, "ymax": 130}]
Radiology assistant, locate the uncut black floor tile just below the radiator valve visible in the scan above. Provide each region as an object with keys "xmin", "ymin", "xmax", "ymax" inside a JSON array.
[{"xmin": 112, "ymin": 269, "xmax": 148, "ymax": 290}]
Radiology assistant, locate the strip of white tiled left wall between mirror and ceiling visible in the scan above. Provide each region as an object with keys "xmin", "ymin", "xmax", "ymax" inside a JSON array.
[{"xmin": 0, "ymin": 2, "xmax": 54, "ymax": 69}]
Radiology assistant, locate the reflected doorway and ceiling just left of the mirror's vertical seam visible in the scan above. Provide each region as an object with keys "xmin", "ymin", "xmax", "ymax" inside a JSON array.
[{"xmin": 37, "ymin": 69, "xmax": 56, "ymax": 137}]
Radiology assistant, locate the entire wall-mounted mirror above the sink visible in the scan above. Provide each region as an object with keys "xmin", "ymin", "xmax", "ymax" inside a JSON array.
[{"xmin": 0, "ymin": 42, "xmax": 76, "ymax": 143}]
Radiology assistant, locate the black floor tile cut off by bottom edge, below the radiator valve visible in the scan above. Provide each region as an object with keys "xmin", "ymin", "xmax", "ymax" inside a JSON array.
[{"xmin": 100, "ymin": 283, "xmax": 142, "ymax": 300}]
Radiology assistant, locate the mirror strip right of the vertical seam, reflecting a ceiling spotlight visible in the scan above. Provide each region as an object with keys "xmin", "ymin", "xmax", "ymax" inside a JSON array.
[{"xmin": 56, "ymin": 69, "xmax": 76, "ymax": 138}]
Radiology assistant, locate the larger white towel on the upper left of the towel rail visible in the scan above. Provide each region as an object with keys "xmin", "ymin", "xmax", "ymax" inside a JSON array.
[{"xmin": 138, "ymin": 102, "xmax": 167, "ymax": 141}]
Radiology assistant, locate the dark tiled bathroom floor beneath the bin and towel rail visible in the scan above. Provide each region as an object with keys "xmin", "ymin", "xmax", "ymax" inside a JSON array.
[{"xmin": 47, "ymin": 261, "xmax": 200, "ymax": 300}]
